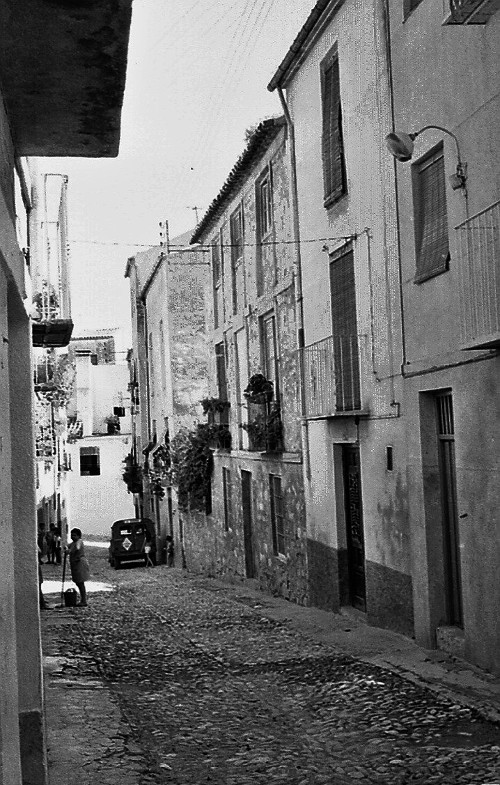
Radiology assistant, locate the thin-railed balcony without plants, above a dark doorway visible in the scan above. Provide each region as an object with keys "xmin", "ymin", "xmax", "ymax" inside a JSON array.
[{"xmin": 302, "ymin": 335, "xmax": 365, "ymax": 419}]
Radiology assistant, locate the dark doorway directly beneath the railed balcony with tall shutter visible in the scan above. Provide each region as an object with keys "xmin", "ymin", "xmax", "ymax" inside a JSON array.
[{"xmin": 342, "ymin": 444, "xmax": 366, "ymax": 611}]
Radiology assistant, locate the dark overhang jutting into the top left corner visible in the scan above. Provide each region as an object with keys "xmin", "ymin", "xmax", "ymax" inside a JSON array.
[{"xmin": 0, "ymin": 0, "xmax": 132, "ymax": 157}]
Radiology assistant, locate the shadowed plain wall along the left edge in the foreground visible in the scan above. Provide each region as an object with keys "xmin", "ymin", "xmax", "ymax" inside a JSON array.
[{"xmin": 0, "ymin": 96, "xmax": 47, "ymax": 785}]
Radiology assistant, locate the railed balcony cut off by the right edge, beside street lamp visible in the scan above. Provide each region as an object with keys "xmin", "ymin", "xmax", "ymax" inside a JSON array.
[{"xmin": 456, "ymin": 201, "xmax": 500, "ymax": 349}]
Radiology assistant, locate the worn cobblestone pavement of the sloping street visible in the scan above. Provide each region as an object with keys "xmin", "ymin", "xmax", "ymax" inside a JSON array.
[{"xmin": 43, "ymin": 550, "xmax": 500, "ymax": 785}]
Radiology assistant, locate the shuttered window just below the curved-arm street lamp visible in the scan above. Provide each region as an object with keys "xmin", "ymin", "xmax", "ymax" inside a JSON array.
[{"xmin": 413, "ymin": 146, "xmax": 450, "ymax": 283}]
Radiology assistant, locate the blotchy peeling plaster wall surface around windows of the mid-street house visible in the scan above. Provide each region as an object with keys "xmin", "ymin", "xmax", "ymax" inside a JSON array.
[{"xmin": 185, "ymin": 128, "xmax": 309, "ymax": 604}]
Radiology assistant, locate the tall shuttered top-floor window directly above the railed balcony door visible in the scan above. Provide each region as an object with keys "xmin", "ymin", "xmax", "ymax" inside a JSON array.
[{"xmin": 321, "ymin": 56, "xmax": 347, "ymax": 207}]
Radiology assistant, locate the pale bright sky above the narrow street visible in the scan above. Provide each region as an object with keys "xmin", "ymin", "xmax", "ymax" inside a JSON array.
[{"xmin": 41, "ymin": 0, "xmax": 315, "ymax": 357}]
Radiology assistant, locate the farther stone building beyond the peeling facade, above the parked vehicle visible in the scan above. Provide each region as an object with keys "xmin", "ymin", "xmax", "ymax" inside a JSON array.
[{"xmin": 125, "ymin": 233, "xmax": 210, "ymax": 565}]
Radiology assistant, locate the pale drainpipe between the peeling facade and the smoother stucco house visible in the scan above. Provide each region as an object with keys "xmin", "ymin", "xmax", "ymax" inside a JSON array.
[{"xmin": 278, "ymin": 85, "xmax": 311, "ymax": 480}]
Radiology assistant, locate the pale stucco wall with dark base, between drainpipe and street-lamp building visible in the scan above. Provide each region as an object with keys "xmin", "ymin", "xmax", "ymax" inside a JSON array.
[{"xmin": 287, "ymin": 0, "xmax": 412, "ymax": 632}]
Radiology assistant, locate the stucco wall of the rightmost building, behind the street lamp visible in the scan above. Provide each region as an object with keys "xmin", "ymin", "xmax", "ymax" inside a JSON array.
[{"xmin": 390, "ymin": 0, "xmax": 500, "ymax": 672}]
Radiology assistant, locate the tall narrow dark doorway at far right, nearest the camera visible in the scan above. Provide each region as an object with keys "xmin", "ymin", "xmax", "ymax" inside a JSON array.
[{"xmin": 436, "ymin": 392, "xmax": 463, "ymax": 627}]
